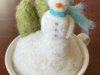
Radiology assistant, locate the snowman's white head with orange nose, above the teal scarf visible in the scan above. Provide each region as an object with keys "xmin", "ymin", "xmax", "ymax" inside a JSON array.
[{"xmin": 47, "ymin": 0, "xmax": 74, "ymax": 12}]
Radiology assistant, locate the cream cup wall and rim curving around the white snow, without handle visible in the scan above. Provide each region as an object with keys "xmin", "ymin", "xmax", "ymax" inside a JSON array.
[{"xmin": 5, "ymin": 35, "xmax": 89, "ymax": 75}]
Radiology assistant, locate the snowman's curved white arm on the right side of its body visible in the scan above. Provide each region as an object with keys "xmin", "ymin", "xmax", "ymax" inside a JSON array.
[{"xmin": 66, "ymin": 16, "xmax": 75, "ymax": 39}]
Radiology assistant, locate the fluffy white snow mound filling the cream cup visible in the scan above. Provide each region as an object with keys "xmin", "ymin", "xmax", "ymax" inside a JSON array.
[{"xmin": 12, "ymin": 31, "xmax": 82, "ymax": 75}]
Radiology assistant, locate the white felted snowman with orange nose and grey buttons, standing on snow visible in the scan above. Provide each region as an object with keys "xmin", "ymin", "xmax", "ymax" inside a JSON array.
[{"xmin": 41, "ymin": 0, "xmax": 74, "ymax": 38}]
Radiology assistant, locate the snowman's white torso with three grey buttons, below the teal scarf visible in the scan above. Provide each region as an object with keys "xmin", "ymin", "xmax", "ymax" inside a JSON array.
[{"xmin": 41, "ymin": 11, "xmax": 69, "ymax": 39}]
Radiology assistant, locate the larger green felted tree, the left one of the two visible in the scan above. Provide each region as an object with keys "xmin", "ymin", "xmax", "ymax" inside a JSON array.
[{"xmin": 16, "ymin": 0, "xmax": 40, "ymax": 36}]
